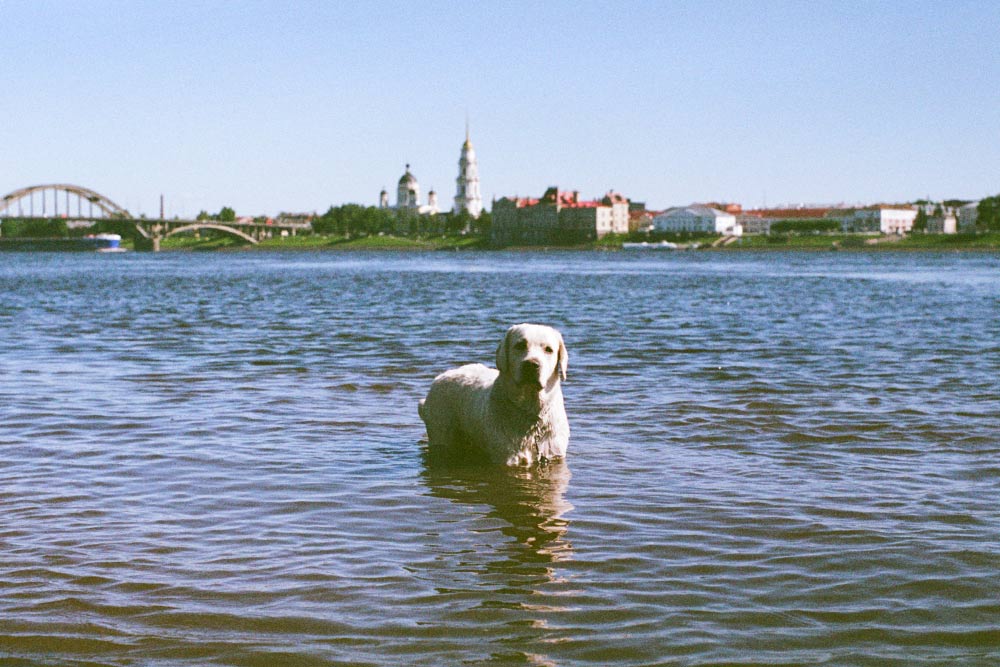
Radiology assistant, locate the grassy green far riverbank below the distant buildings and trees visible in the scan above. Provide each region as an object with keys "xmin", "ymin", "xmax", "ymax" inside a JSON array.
[{"xmin": 107, "ymin": 232, "xmax": 1000, "ymax": 252}]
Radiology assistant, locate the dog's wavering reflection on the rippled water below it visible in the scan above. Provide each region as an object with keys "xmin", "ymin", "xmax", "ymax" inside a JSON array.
[{"xmin": 423, "ymin": 460, "xmax": 573, "ymax": 587}]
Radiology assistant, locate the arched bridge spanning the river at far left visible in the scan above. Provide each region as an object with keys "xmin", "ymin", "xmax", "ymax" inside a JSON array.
[{"xmin": 0, "ymin": 183, "xmax": 310, "ymax": 251}]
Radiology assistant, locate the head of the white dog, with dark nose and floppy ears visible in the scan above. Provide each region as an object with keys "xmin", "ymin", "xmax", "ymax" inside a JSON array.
[{"xmin": 497, "ymin": 324, "xmax": 569, "ymax": 393}]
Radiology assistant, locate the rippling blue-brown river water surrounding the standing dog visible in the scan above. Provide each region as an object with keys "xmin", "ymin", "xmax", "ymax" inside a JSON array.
[{"xmin": 0, "ymin": 252, "xmax": 1000, "ymax": 666}]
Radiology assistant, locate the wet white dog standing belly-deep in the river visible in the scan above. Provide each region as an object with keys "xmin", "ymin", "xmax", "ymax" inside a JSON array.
[{"xmin": 419, "ymin": 324, "xmax": 569, "ymax": 465}]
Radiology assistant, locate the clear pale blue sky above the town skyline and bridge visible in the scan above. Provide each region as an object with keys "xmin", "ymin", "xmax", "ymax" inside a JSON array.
[{"xmin": 0, "ymin": 0, "xmax": 1000, "ymax": 216}]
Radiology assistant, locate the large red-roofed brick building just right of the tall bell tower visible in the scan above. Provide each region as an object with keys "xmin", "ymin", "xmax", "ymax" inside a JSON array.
[{"xmin": 491, "ymin": 187, "xmax": 629, "ymax": 245}]
